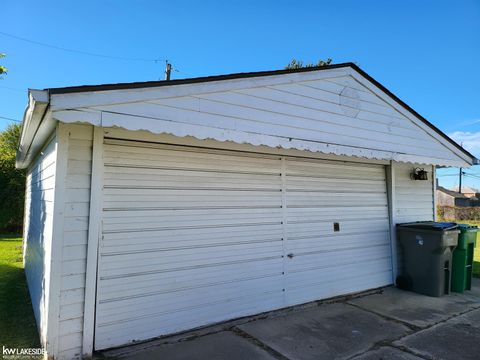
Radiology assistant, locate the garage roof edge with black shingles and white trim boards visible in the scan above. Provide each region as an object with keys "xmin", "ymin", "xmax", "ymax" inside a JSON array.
[{"xmin": 17, "ymin": 62, "xmax": 478, "ymax": 167}]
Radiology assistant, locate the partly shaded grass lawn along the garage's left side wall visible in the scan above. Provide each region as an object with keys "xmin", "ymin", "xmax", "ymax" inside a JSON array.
[{"xmin": 0, "ymin": 235, "xmax": 40, "ymax": 348}]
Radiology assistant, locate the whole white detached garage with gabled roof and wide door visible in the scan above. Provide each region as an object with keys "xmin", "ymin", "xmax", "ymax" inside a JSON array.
[{"xmin": 17, "ymin": 63, "xmax": 477, "ymax": 359}]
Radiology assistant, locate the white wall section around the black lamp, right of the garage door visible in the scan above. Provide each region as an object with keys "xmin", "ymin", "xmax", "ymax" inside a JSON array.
[{"xmin": 394, "ymin": 163, "xmax": 435, "ymax": 274}]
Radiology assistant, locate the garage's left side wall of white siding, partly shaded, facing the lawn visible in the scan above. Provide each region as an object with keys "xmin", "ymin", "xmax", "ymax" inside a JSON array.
[{"xmin": 23, "ymin": 138, "xmax": 56, "ymax": 344}]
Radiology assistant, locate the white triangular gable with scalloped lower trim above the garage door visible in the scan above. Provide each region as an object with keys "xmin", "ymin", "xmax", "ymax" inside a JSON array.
[{"xmin": 52, "ymin": 70, "xmax": 466, "ymax": 163}]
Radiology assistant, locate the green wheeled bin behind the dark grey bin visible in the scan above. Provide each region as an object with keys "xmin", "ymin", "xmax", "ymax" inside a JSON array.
[{"xmin": 452, "ymin": 224, "xmax": 478, "ymax": 293}]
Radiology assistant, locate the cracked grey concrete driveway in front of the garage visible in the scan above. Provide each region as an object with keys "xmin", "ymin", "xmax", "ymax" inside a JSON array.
[{"xmin": 98, "ymin": 279, "xmax": 480, "ymax": 360}]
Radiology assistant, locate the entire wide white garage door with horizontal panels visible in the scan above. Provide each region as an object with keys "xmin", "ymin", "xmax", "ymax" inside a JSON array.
[{"xmin": 95, "ymin": 139, "xmax": 392, "ymax": 349}]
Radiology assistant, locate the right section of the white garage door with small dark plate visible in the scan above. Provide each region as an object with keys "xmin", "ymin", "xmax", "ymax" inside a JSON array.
[{"xmin": 285, "ymin": 160, "xmax": 392, "ymax": 305}]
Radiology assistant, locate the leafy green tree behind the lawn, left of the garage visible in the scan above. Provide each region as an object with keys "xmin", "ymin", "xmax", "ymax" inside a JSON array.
[{"xmin": 0, "ymin": 124, "xmax": 25, "ymax": 232}]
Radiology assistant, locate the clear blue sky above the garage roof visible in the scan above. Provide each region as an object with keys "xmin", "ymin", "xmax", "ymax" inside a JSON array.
[{"xmin": 0, "ymin": 0, "xmax": 480, "ymax": 188}]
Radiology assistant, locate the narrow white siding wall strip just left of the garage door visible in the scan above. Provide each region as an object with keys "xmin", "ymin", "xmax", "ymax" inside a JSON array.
[{"xmin": 55, "ymin": 124, "xmax": 93, "ymax": 359}]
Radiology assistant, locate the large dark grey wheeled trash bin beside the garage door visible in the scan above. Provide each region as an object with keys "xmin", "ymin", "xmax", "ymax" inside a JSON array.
[{"xmin": 397, "ymin": 221, "xmax": 460, "ymax": 297}]
